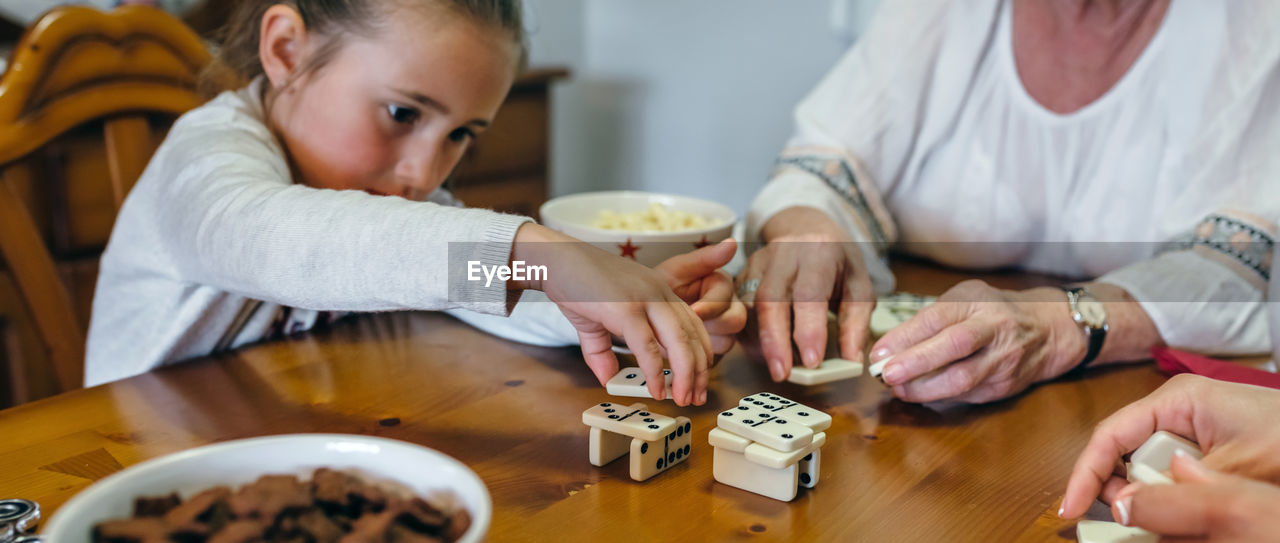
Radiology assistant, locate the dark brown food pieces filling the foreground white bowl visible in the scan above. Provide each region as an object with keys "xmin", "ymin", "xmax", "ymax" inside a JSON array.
[{"xmin": 93, "ymin": 467, "xmax": 471, "ymax": 543}]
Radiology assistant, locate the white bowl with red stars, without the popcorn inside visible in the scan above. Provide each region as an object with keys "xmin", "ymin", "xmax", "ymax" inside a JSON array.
[{"xmin": 539, "ymin": 191, "xmax": 737, "ymax": 266}]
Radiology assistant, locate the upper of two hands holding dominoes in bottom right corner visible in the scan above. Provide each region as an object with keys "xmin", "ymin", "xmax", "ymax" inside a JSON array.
[{"xmin": 1061, "ymin": 374, "xmax": 1280, "ymax": 519}]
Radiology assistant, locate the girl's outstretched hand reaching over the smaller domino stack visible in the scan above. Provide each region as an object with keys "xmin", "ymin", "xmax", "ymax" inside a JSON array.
[{"xmin": 508, "ymin": 224, "xmax": 714, "ymax": 406}]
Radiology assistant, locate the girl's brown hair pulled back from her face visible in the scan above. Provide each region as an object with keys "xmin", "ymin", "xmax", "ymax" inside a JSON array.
[{"xmin": 200, "ymin": 0, "xmax": 527, "ymax": 96}]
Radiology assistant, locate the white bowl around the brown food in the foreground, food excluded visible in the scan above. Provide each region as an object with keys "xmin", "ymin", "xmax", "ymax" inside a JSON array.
[{"xmin": 42, "ymin": 434, "xmax": 493, "ymax": 543}]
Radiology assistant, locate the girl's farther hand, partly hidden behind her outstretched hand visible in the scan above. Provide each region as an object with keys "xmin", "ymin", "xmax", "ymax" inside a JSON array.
[{"xmin": 655, "ymin": 238, "xmax": 746, "ymax": 365}]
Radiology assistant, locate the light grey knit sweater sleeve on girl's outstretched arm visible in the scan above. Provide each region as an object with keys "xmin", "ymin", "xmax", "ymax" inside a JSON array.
[{"xmin": 142, "ymin": 108, "xmax": 531, "ymax": 314}]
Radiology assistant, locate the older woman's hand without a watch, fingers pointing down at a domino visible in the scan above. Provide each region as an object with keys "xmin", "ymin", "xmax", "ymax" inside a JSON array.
[{"xmin": 737, "ymin": 207, "xmax": 876, "ymax": 382}]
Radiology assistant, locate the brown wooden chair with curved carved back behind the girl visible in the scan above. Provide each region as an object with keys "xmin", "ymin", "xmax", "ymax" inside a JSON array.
[{"xmin": 0, "ymin": 6, "xmax": 210, "ymax": 405}]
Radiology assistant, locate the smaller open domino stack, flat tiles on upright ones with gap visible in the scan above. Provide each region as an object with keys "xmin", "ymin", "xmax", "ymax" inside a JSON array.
[{"xmin": 582, "ymin": 402, "xmax": 694, "ymax": 480}]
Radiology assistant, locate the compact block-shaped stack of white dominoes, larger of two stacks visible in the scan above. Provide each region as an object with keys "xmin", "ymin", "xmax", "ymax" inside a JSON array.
[{"xmin": 708, "ymin": 392, "xmax": 831, "ymax": 502}]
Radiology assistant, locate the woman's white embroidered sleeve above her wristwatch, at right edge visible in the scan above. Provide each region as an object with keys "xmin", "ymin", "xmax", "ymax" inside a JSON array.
[{"xmin": 1098, "ymin": 16, "xmax": 1280, "ymax": 355}]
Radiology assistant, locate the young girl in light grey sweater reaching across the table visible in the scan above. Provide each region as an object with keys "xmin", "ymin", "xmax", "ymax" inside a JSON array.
[{"xmin": 86, "ymin": 0, "xmax": 745, "ymax": 405}]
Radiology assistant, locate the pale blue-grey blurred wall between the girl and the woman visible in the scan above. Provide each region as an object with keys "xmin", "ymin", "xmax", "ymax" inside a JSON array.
[{"xmin": 526, "ymin": 0, "xmax": 878, "ymax": 213}]
